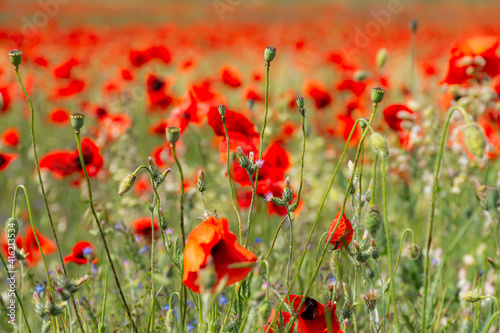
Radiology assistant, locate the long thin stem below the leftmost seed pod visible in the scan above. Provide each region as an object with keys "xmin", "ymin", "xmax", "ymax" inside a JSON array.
[{"xmin": 14, "ymin": 66, "xmax": 85, "ymax": 333}]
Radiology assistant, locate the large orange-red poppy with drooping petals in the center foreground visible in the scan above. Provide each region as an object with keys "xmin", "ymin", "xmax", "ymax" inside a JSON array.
[{"xmin": 182, "ymin": 216, "xmax": 257, "ymax": 293}]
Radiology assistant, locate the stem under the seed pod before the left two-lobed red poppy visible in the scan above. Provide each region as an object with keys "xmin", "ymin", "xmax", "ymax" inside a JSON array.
[{"xmin": 75, "ymin": 131, "xmax": 138, "ymax": 333}]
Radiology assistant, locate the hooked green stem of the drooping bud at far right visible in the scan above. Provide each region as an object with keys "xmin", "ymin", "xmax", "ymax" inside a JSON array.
[{"xmin": 422, "ymin": 105, "xmax": 470, "ymax": 333}]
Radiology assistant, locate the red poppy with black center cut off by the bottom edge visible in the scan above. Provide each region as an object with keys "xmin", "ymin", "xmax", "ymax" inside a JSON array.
[{"xmin": 264, "ymin": 295, "xmax": 343, "ymax": 333}]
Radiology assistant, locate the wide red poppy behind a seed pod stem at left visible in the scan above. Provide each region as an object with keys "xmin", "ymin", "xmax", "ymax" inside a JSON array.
[{"xmin": 40, "ymin": 138, "xmax": 104, "ymax": 177}]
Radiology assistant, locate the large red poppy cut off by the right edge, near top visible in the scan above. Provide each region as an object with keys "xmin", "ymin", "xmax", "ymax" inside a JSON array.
[{"xmin": 442, "ymin": 36, "xmax": 500, "ymax": 84}]
